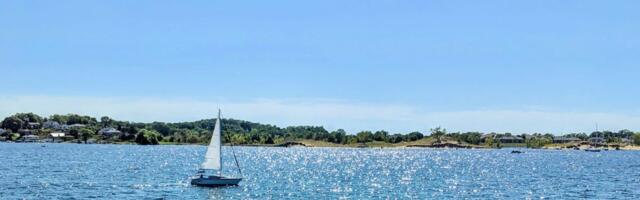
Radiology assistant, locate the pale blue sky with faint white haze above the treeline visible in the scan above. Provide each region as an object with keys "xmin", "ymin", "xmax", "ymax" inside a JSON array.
[{"xmin": 0, "ymin": 0, "xmax": 640, "ymax": 133}]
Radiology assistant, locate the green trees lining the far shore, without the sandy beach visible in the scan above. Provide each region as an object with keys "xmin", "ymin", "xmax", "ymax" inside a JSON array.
[{"xmin": 0, "ymin": 113, "xmax": 640, "ymax": 147}]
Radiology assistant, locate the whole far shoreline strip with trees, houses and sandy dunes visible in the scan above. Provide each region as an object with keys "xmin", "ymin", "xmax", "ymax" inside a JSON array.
[{"xmin": 0, "ymin": 113, "xmax": 640, "ymax": 150}]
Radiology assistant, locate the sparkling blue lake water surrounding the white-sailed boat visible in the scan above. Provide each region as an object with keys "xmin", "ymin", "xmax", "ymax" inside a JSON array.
[{"xmin": 0, "ymin": 143, "xmax": 640, "ymax": 199}]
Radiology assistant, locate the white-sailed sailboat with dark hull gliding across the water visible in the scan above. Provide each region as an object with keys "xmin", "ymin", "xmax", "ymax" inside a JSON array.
[{"xmin": 191, "ymin": 110, "xmax": 242, "ymax": 187}]
